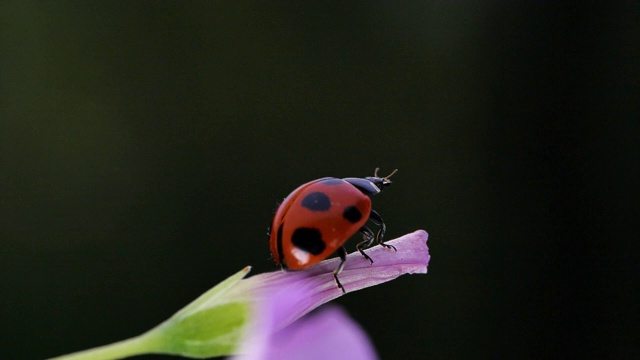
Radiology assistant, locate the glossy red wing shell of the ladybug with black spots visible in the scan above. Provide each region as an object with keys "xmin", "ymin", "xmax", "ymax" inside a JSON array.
[{"xmin": 269, "ymin": 177, "xmax": 371, "ymax": 270}]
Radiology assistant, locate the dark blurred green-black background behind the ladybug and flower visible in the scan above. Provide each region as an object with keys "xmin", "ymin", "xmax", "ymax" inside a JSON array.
[{"xmin": 0, "ymin": 1, "xmax": 640, "ymax": 359}]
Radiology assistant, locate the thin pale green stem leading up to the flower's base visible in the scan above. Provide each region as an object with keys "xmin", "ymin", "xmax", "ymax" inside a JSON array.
[{"xmin": 50, "ymin": 331, "xmax": 159, "ymax": 360}]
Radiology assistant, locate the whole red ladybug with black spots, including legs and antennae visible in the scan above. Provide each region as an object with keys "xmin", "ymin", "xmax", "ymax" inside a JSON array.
[{"xmin": 269, "ymin": 168, "xmax": 398, "ymax": 293}]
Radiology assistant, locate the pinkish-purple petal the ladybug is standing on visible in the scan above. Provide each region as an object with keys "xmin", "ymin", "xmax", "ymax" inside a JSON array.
[{"xmin": 230, "ymin": 230, "xmax": 429, "ymax": 330}]
